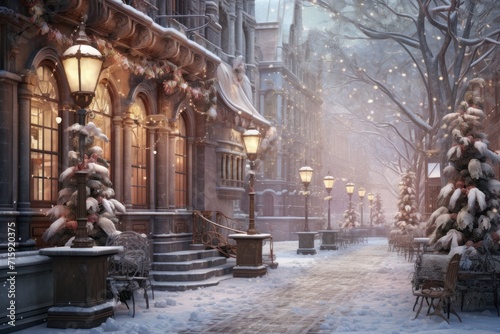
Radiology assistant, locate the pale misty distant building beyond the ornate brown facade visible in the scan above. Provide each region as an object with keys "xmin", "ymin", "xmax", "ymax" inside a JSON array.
[{"xmin": 255, "ymin": 0, "xmax": 326, "ymax": 238}]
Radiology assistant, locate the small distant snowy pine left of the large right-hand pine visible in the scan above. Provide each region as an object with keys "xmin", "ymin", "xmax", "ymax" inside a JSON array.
[{"xmin": 393, "ymin": 171, "xmax": 421, "ymax": 236}]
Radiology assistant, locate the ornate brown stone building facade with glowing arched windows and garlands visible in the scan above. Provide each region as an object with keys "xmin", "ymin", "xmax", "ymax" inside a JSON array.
[{"xmin": 0, "ymin": 0, "xmax": 270, "ymax": 248}]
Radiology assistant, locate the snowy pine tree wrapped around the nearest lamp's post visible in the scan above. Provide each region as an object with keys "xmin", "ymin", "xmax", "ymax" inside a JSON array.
[{"xmin": 42, "ymin": 122, "xmax": 125, "ymax": 246}]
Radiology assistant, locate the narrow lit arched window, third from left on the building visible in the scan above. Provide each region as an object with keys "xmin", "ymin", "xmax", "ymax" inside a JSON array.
[{"xmin": 130, "ymin": 97, "xmax": 148, "ymax": 208}]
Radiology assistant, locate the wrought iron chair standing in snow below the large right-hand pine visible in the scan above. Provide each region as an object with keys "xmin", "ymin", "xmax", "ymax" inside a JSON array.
[{"xmin": 413, "ymin": 254, "xmax": 462, "ymax": 323}]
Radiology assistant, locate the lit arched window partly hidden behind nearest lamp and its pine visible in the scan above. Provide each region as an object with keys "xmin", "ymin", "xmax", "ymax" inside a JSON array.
[{"xmin": 88, "ymin": 83, "xmax": 112, "ymax": 163}]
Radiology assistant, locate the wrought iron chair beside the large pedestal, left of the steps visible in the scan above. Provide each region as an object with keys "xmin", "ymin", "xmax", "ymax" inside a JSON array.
[{"xmin": 106, "ymin": 231, "xmax": 154, "ymax": 317}]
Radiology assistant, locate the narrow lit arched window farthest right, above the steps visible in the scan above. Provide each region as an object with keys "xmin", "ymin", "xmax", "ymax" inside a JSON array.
[{"xmin": 175, "ymin": 116, "xmax": 188, "ymax": 208}]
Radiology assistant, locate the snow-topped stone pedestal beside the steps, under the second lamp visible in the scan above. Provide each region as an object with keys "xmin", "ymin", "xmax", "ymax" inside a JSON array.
[{"xmin": 228, "ymin": 233, "xmax": 271, "ymax": 277}]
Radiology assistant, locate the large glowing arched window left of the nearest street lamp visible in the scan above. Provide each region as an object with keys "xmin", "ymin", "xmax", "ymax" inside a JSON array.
[{"xmin": 30, "ymin": 66, "xmax": 60, "ymax": 205}]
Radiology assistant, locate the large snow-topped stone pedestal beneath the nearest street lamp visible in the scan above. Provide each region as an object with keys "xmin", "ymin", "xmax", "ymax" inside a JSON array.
[{"xmin": 40, "ymin": 247, "xmax": 122, "ymax": 329}]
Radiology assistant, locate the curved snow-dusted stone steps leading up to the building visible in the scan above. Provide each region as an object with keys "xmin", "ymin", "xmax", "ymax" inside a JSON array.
[{"xmin": 150, "ymin": 249, "xmax": 236, "ymax": 291}]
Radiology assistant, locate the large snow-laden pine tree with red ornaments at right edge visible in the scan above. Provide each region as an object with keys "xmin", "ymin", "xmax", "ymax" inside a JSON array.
[{"xmin": 426, "ymin": 79, "xmax": 500, "ymax": 254}]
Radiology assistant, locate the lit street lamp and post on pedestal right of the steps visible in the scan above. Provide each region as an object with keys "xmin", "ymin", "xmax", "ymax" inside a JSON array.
[{"xmin": 243, "ymin": 123, "xmax": 262, "ymax": 234}]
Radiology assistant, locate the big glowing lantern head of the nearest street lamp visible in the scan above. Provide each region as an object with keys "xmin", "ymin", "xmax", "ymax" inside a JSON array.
[{"xmin": 61, "ymin": 24, "xmax": 104, "ymax": 108}]
